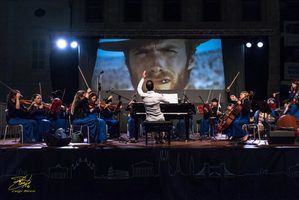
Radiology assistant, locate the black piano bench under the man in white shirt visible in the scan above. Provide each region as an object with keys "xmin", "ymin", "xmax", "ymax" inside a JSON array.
[{"xmin": 143, "ymin": 121, "xmax": 173, "ymax": 145}]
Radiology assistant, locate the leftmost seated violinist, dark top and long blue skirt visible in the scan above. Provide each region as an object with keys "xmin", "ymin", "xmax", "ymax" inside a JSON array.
[{"xmin": 6, "ymin": 90, "xmax": 37, "ymax": 143}]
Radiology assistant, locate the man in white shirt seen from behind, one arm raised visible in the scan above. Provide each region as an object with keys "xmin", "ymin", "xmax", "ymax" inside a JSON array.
[{"xmin": 137, "ymin": 71, "xmax": 169, "ymax": 143}]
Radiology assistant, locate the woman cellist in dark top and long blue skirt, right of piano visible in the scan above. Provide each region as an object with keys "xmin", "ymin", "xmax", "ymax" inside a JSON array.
[{"xmin": 224, "ymin": 91, "xmax": 251, "ymax": 142}]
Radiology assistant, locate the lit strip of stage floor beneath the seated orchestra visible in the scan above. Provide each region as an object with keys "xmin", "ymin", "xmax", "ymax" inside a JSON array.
[{"xmin": 0, "ymin": 134, "xmax": 299, "ymax": 149}]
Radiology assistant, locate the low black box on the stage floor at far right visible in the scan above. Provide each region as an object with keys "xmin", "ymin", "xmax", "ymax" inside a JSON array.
[{"xmin": 269, "ymin": 130, "xmax": 295, "ymax": 144}]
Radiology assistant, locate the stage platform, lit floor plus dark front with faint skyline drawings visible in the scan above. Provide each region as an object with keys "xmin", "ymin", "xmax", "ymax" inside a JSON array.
[{"xmin": 0, "ymin": 136, "xmax": 299, "ymax": 200}]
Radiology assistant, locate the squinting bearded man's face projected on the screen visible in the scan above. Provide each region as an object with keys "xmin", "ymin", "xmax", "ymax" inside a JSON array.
[{"xmin": 128, "ymin": 39, "xmax": 189, "ymax": 90}]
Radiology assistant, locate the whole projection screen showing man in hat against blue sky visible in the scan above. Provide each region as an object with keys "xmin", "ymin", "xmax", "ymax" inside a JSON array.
[{"xmin": 93, "ymin": 39, "xmax": 224, "ymax": 90}]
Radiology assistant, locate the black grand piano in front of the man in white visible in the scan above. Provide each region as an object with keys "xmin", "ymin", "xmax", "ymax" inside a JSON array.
[{"xmin": 131, "ymin": 103, "xmax": 196, "ymax": 140}]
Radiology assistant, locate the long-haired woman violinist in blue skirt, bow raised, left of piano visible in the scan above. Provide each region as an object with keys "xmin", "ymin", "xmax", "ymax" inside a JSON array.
[{"xmin": 71, "ymin": 88, "xmax": 104, "ymax": 143}]
